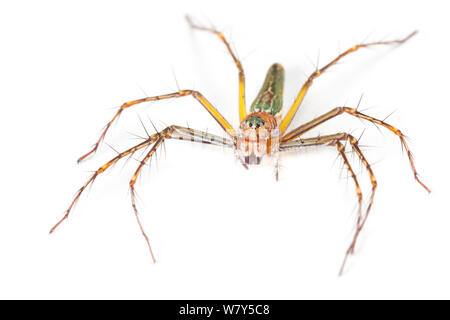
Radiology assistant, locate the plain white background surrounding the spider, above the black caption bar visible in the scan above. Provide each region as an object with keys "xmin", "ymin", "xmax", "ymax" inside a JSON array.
[{"xmin": 0, "ymin": 1, "xmax": 450, "ymax": 299}]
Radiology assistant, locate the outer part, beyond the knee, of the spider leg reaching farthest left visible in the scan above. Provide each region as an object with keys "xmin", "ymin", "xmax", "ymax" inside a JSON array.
[{"xmin": 50, "ymin": 134, "xmax": 158, "ymax": 233}]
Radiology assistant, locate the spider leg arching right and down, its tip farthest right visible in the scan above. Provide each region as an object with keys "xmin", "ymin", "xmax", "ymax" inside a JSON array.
[{"xmin": 281, "ymin": 107, "xmax": 431, "ymax": 192}]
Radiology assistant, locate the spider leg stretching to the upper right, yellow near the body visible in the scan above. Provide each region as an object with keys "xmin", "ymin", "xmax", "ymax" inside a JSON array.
[{"xmin": 280, "ymin": 31, "xmax": 417, "ymax": 133}]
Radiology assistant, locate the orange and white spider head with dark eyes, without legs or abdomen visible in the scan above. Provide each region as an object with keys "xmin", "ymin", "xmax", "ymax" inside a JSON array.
[{"xmin": 236, "ymin": 112, "xmax": 279, "ymax": 165}]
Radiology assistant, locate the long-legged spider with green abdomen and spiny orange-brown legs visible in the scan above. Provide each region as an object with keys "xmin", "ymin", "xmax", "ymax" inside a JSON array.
[{"xmin": 50, "ymin": 16, "xmax": 430, "ymax": 275}]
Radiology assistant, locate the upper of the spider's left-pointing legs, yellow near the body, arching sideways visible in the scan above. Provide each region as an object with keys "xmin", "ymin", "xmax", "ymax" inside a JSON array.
[{"xmin": 78, "ymin": 90, "xmax": 235, "ymax": 162}]
